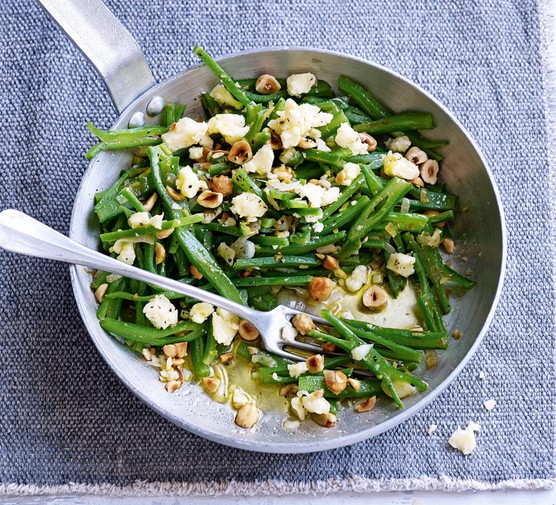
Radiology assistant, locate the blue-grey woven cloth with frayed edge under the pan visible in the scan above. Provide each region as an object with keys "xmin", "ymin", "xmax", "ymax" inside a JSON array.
[{"xmin": 0, "ymin": 0, "xmax": 556, "ymax": 494}]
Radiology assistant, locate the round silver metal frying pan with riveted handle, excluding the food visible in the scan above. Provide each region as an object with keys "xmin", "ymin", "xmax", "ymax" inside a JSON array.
[{"xmin": 39, "ymin": 0, "xmax": 506, "ymax": 453}]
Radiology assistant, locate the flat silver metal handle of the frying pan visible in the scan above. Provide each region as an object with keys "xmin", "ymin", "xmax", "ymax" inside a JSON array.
[{"xmin": 39, "ymin": 0, "xmax": 155, "ymax": 113}]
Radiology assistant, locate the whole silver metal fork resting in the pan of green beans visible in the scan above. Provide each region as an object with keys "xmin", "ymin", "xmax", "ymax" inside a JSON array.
[{"xmin": 0, "ymin": 209, "xmax": 328, "ymax": 361}]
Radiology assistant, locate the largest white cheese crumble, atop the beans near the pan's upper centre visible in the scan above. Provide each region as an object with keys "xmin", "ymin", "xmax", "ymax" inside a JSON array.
[{"xmin": 268, "ymin": 98, "xmax": 333, "ymax": 149}]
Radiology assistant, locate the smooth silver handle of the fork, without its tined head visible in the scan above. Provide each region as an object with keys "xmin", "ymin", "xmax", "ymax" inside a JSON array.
[{"xmin": 0, "ymin": 209, "xmax": 257, "ymax": 320}]
